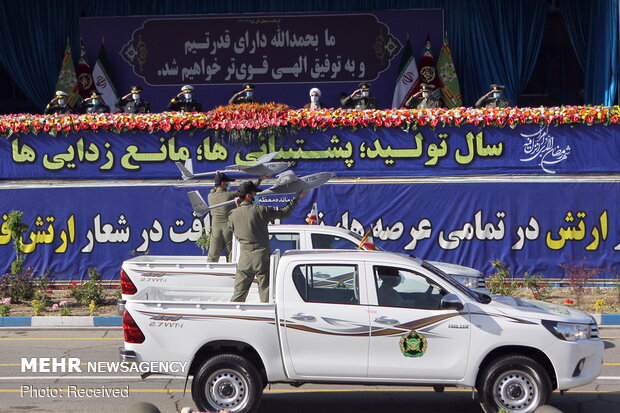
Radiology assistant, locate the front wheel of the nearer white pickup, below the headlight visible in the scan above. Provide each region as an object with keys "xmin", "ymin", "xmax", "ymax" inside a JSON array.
[{"xmin": 477, "ymin": 355, "xmax": 552, "ymax": 413}]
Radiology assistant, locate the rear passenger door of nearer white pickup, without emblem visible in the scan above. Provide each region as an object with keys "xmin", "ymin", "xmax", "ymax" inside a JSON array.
[{"xmin": 279, "ymin": 263, "xmax": 369, "ymax": 378}]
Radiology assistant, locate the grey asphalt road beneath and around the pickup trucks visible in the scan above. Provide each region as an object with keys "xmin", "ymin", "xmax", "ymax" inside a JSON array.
[{"xmin": 0, "ymin": 327, "xmax": 620, "ymax": 413}]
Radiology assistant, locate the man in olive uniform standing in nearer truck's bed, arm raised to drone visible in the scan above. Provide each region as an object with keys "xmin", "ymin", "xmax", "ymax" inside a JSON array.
[{"xmin": 228, "ymin": 181, "xmax": 305, "ymax": 303}]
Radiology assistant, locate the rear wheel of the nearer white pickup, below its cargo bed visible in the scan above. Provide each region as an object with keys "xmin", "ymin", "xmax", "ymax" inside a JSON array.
[{"xmin": 192, "ymin": 354, "xmax": 263, "ymax": 413}]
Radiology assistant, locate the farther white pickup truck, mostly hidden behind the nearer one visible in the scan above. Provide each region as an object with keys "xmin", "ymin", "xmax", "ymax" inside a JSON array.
[{"xmin": 120, "ymin": 224, "xmax": 486, "ymax": 300}]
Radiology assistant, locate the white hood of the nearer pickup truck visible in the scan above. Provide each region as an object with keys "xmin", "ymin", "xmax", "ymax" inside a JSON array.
[{"xmin": 484, "ymin": 295, "xmax": 596, "ymax": 324}]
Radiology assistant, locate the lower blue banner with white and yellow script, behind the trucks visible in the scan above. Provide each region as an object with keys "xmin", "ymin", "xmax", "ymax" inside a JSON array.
[{"xmin": 0, "ymin": 183, "xmax": 620, "ymax": 280}]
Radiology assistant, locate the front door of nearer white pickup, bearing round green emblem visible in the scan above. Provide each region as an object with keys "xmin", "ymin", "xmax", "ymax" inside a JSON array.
[{"xmin": 368, "ymin": 265, "xmax": 471, "ymax": 380}]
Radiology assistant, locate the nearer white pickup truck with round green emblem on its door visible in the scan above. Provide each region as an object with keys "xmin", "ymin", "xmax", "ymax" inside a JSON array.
[{"xmin": 120, "ymin": 250, "xmax": 604, "ymax": 413}]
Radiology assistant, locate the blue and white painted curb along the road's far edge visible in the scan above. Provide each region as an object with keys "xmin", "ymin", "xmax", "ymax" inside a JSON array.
[{"xmin": 0, "ymin": 314, "xmax": 620, "ymax": 328}]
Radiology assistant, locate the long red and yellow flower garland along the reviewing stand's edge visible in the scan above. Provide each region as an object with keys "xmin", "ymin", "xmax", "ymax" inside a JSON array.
[{"xmin": 0, "ymin": 103, "xmax": 620, "ymax": 140}]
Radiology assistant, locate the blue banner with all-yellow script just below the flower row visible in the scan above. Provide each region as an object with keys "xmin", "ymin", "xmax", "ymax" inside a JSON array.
[{"xmin": 0, "ymin": 125, "xmax": 620, "ymax": 179}]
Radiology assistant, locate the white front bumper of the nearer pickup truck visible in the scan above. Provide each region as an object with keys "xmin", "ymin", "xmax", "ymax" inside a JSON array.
[{"xmin": 545, "ymin": 340, "xmax": 605, "ymax": 390}]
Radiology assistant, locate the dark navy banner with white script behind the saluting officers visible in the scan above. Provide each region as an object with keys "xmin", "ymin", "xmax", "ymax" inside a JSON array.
[{"xmin": 80, "ymin": 9, "xmax": 444, "ymax": 112}]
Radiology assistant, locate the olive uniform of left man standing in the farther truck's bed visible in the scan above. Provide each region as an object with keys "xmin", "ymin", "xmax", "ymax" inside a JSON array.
[{"xmin": 207, "ymin": 187, "xmax": 236, "ymax": 262}]
